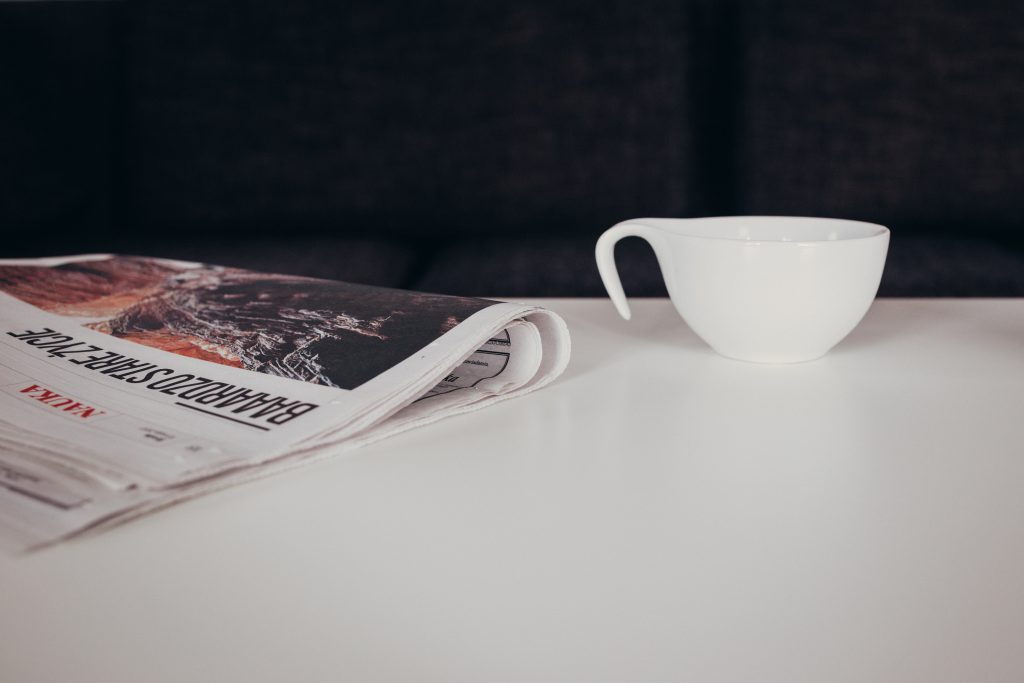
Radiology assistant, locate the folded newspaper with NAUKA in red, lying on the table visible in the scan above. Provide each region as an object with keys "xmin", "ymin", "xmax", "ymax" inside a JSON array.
[{"xmin": 0, "ymin": 255, "xmax": 569, "ymax": 548}]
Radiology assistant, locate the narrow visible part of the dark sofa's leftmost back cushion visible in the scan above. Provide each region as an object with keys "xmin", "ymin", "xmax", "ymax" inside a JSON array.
[{"xmin": 0, "ymin": 2, "xmax": 120, "ymax": 242}]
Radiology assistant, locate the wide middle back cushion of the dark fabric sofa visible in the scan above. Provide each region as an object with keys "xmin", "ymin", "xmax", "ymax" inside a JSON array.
[{"xmin": 117, "ymin": 0, "xmax": 697, "ymax": 240}]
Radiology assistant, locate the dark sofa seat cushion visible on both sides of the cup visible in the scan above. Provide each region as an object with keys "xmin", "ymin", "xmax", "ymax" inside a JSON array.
[{"xmin": 414, "ymin": 234, "xmax": 1024, "ymax": 297}]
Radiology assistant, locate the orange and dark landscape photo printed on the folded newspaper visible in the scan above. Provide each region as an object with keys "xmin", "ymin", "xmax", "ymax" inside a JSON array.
[{"xmin": 0, "ymin": 256, "xmax": 494, "ymax": 389}]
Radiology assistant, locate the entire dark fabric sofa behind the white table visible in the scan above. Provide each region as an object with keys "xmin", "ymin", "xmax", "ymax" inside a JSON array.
[{"xmin": 0, "ymin": 0, "xmax": 1024, "ymax": 296}]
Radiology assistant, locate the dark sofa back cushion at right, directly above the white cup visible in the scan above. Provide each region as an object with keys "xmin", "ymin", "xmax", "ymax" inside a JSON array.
[{"xmin": 736, "ymin": 0, "xmax": 1024, "ymax": 242}]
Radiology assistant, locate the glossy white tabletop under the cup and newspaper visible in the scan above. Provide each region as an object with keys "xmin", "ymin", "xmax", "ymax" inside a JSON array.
[{"xmin": 0, "ymin": 299, "xmax": 1024, "ymax": 683}]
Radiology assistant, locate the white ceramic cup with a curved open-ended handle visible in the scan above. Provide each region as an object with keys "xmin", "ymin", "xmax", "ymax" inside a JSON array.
[{"xmin": 597, "ymin": 216, "xmax": 889, "ymax": 362}]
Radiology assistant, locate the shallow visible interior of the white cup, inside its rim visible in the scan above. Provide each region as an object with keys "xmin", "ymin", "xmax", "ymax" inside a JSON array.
[{"xmin": 666, "ymin": 216, "xmax": 888, "ymax": 243}]
